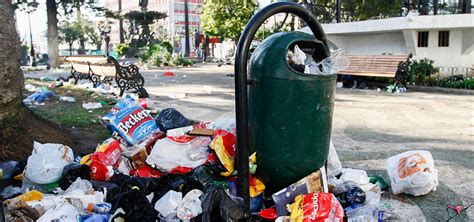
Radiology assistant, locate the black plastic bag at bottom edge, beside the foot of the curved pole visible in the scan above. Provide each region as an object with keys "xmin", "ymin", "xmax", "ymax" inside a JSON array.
[{"xmin": 201, "ymin": 187, "xmax": 250, "ymax": 222}]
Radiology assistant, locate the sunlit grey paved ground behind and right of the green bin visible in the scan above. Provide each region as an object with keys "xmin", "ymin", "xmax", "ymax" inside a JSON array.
[{"xmin": 26, "ymin": 64, "xmax": 474, "ymax": 221}]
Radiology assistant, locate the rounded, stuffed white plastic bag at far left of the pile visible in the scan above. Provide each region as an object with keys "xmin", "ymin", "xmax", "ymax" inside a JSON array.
[{"xmin": 25, "ymin": 141, "xmax": 74, "ymax": 184}]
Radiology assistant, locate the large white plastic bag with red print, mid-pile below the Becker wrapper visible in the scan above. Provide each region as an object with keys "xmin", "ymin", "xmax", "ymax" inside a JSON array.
[{"xmin": 146, "ymin": 136, "xmax": 211, "ymax": 172}]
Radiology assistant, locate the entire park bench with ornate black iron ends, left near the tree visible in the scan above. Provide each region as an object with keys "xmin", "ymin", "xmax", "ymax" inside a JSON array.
[{"xmin": 64, "ymin": 55, "xmax": 147, "ymax": 96}]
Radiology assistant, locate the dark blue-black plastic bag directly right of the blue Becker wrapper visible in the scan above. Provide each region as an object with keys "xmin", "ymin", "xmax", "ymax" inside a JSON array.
[{"xmin": 155, "ymin": 108, "xmax": 189, "ymax": 132}]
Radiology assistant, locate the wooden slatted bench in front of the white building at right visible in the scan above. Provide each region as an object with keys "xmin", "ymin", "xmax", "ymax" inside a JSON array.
[{"xmin": 338, "ymin": 54, "xmax": 412, "ymax": 85}]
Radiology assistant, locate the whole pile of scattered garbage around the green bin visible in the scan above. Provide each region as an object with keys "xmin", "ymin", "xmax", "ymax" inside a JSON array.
[{"xmin": 0, "ymin": 95, "xmax": 438, "ymax": 221}]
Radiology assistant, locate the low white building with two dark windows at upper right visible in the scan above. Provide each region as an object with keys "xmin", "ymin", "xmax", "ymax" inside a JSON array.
[{"xmin": 305, "ymin": 14, "xmax": 474, "ymax": 74}]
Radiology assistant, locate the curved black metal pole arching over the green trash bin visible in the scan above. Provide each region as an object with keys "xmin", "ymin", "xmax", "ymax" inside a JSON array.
[{"xmin": 234, "ymin": 2, "xmax": 329, "ymax": 215}]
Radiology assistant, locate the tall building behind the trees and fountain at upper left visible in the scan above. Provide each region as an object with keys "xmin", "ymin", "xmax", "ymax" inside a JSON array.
[{"xmin": 105, "ymin": 0, "xmax": 203, "ymax": 51}]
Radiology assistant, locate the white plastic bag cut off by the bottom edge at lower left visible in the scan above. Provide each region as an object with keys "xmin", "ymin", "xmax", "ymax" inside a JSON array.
[{"xmin": 38, "ymin": 203, "xmax": 79, "ymax": 222}]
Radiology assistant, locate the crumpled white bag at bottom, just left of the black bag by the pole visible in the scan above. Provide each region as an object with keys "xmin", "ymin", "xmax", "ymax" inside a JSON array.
[{"xmin": 177, "ymin": 189, "xmax": 203, "ymax": 220}]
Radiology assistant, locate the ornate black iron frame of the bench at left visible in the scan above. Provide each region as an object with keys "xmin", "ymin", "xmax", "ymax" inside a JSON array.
[{"xmin": 65, "ymin": 56, "xmax": 145, "ymax": 96}]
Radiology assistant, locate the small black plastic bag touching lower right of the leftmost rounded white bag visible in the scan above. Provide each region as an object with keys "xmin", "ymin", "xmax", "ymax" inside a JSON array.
[{"xmin": 59, "ymin": 163, "xmax": 91, "ymax": 190}]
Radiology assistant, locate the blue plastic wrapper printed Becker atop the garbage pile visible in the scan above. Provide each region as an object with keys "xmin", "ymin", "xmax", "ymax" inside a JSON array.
[{"xmin": 104, "ymin": 95, "xmax": 158, "ymax": 145}]
